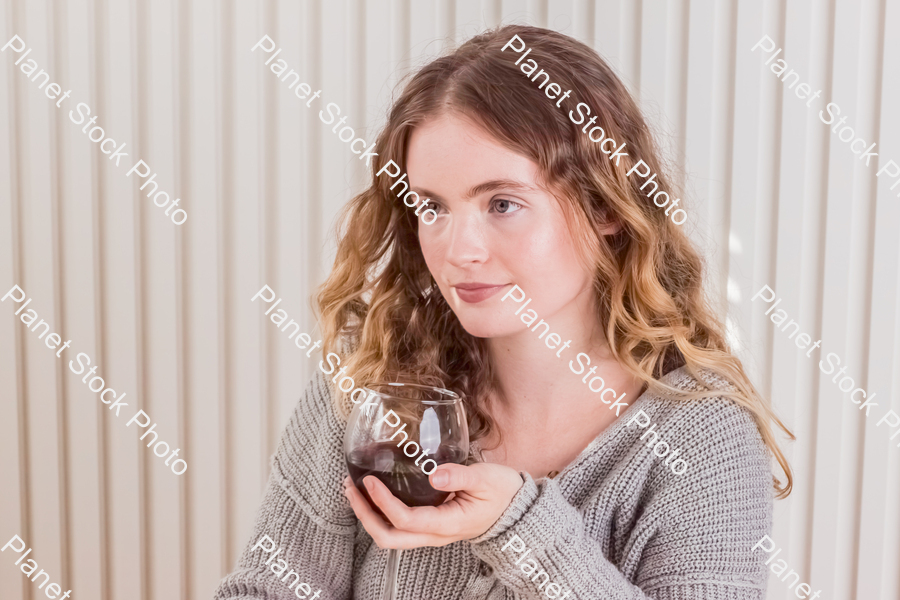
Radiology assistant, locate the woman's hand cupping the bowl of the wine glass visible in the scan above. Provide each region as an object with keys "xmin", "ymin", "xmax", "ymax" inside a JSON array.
[{"xmin": 344, "ymin": 463, "xmax": 524, "ymax": 549}]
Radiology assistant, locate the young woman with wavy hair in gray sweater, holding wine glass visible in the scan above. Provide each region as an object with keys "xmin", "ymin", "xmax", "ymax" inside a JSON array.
[{"xmin": 217, "ymin": 26, "xmax": 791, "ymax": 600}]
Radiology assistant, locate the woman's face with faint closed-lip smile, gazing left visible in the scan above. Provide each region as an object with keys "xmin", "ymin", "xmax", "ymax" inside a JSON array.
[{"xmin": 410, "ymin": 114, "xmax": 592, "ymax": 338}]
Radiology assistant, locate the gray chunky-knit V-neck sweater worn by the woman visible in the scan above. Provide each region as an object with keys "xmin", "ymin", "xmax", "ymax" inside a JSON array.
[{"xmin": 216, "ymin": 369, "xmax": 773, "ymax": 600}]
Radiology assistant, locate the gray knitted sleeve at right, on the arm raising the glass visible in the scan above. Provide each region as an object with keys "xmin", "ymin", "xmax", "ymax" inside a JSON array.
[{"xmin": 471, "ymin": 399, "xmax": 773, "ymax": 600}]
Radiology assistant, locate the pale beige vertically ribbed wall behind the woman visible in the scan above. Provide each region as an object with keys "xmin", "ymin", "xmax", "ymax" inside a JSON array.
[{"xmin": 0, "ymin": 0, "xmax": 900, "ymax": 600}]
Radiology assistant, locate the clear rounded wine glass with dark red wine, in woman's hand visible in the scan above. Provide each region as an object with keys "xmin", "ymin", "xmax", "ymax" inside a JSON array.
[{"xmin": 344, "ymin": 383, "xmax": 469, "ymax": 600}]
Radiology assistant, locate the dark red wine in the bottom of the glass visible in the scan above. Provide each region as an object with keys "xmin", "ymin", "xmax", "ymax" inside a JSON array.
[{"xmin": 347, "ymin": 442, "xmax": 466, "ymax": 513}]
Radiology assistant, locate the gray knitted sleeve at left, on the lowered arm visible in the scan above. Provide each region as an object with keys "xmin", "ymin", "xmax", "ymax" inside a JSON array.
[{"xmin": 215, "ymin": 372, "xmax": 356, "ymax": 600}]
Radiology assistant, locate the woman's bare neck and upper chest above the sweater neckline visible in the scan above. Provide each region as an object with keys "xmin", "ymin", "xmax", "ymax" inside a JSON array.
[{"xmin": 483, "ymin": 288, "xmax": 643, "ymax": 477}]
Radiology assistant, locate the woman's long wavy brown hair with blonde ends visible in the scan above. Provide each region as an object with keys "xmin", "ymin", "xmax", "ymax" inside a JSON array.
[{"xmin": 316, "ymin": 25, "xmax": 793, "ymax": 497}]
